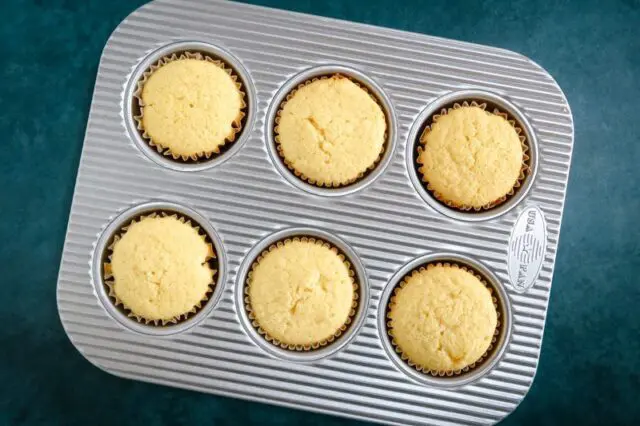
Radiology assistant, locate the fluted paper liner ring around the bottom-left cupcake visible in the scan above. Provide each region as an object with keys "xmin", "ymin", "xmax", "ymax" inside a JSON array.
[{"xmin": 102, "ymin": 210, "xmax": 218, "ymax": 327}]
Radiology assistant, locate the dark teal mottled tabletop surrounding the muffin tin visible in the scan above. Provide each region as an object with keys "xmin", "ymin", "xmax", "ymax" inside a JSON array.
[{"xmin": 0, "ymin": 0, "xmax": 640, "ymax": 426}]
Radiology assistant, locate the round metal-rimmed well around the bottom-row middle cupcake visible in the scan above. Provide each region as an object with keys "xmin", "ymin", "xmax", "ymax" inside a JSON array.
[{"xmin": 236, "ymin": 228, "xmax": 369, "ymax": 362}]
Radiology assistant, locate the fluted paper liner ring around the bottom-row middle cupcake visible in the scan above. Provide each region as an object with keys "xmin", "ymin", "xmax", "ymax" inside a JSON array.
[{"xmin": 243, "ymin": 236, "xmax": 360, "ymax": 352}]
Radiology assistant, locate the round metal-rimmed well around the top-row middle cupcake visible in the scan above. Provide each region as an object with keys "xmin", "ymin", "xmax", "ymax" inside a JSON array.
[{"xmin": 265, "ymin": 64, "xmax": 398, "ymax": 197}]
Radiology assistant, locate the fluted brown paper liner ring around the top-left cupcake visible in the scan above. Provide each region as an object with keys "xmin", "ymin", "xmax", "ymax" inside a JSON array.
[{"xmin": 133, "ymin": 51, "xmax": 247, "ymax": 163}]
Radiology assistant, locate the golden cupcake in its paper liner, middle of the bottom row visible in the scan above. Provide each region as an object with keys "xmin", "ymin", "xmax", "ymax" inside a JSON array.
[{"xmin": 245, "ymin": 237, "xmax": 357, "ymax": 350}]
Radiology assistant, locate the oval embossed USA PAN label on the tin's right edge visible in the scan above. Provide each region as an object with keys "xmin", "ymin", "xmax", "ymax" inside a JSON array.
[{"xmin": 507, "ymin": 207, "xmax": 547, "ymax": 293}]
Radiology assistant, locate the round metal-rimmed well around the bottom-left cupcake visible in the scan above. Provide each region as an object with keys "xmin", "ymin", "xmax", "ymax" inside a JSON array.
[{"xmin": 91, "ymin": 202, "xmax": 226, "ymax": 336}]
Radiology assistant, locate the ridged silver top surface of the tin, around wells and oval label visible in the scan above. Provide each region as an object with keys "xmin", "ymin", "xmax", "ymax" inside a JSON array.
[{"xmin": 58, "ymin": 0, "xmax": 573, "ymax": 424}]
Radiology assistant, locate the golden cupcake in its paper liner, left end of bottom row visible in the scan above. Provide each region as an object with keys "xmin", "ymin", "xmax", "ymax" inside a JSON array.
[{"xmin": 104, "ymin": 214, "xmax": 216, "ymax": 325}]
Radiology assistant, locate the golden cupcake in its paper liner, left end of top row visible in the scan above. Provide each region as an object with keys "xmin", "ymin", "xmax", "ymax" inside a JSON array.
[{"xmin": 136, "ymin": 52, "xmax": 246, "ymax": 161}]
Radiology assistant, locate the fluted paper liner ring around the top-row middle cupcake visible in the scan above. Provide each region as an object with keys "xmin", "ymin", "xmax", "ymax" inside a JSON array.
[{"xmin": 273, "ymin": 73, "xmax": 389, "ymax": 188}]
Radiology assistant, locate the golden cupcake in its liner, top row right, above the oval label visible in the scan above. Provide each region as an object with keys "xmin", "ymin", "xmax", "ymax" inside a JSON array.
[{"xmin": 417, "ymin": 102, "xmax": 528, "ymax": 210}]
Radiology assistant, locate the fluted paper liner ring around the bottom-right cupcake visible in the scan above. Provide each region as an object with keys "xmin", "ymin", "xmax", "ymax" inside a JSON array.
[{"xmin": 385, "ymin": 262, "xmax": 503, "ymax": 377}]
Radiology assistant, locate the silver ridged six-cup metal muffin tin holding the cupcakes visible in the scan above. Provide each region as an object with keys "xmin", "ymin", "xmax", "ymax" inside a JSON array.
[{"xmin": 57, "ymin": 0, "xmax": 573, "ymax": 424}]
